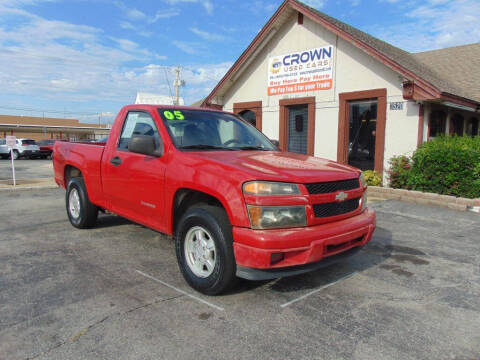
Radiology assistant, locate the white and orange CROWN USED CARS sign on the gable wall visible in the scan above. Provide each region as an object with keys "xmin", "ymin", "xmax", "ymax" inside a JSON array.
[{"xmin": 267, "ymin": 45, "xmax": 334, "ymax": 96}]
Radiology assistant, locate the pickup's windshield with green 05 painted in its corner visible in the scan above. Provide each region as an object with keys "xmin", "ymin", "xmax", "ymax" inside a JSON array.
[{"xmin": 158, "ymin": 109, "xmax": 277, "ymax": 150}]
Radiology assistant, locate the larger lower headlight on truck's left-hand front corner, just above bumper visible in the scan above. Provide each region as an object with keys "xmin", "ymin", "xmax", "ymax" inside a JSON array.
[{"xmin": 247, "ymin": 205, "xmax": 307, "ymax": 229}]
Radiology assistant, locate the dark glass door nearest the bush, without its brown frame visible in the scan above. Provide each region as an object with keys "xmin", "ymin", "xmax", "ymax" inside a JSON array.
[{"xmin": 348, "ymin": 99, "xmax": 377, "ymax": 170}]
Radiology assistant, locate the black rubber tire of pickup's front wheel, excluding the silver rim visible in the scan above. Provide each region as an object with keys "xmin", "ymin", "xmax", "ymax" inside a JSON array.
[{"xmin": 175, "ymin": 204, "xmax": 237, "ymax": 295}]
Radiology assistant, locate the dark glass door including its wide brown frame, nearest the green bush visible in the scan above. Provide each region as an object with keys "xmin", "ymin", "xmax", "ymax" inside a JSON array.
[{"xmin": 337, "ymin": 89, "xmax": 387, "ymax": 174}]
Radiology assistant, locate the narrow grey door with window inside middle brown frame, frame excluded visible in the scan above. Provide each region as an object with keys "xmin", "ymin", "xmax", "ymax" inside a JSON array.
[{"xmin": 287, "ymin": 105, "xmax": 308, "ymax": 154}]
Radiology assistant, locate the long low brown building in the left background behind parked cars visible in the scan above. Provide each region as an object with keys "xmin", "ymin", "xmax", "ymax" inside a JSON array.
[{"xmin": 0, "ymin": 115, "xmax": 110, "ymax": 141}]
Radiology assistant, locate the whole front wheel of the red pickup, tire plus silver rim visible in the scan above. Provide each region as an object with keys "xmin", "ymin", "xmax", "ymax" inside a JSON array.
[{"xmin": 175, "ymin": 204, "xmax": 237, "ymax": 295}]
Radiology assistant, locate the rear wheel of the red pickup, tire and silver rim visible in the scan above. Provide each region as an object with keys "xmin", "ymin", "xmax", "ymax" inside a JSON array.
[{"xmin": 65, "ymin": 178, "xmax": 98, "ymax": 229}]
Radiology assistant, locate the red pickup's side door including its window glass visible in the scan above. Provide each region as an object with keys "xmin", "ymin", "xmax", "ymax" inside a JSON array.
[{"xmin": 102, "ymin": 111, "xmax": 166, "ymax": 229}]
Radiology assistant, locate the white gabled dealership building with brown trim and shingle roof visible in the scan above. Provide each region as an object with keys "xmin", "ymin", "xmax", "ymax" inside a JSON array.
[{"xmin": 202, "ymin": 0, "xmax": 480, "ymax": 179}]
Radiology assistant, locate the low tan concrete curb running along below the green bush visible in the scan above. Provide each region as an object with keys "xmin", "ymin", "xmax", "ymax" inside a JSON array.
[{"xmin": 368, "ymin": 186, "xmax": 480, "ymax": 213}]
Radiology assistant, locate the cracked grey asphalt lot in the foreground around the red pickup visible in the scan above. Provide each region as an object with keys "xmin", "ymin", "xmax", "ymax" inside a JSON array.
[{"xmin": 0, "ymin": 189, "xmax": 480, "ymax": 360}]
